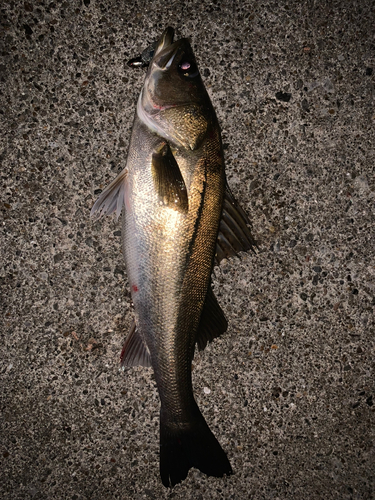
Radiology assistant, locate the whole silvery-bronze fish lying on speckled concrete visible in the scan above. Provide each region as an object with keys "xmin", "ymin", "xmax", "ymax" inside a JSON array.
[{"xmin": 91, "ymin": 27, "xmax": 256, "ymax": 487}]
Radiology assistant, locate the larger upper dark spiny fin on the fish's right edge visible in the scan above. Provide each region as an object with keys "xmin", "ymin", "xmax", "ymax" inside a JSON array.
[{"xmin": 215, "ymin": 184, "xmax": 257, "ymax": 264}]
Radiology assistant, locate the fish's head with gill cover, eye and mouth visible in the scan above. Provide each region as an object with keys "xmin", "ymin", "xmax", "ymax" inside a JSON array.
[{"xmin": 137, "ymin": 28, "xmax": 216, "ymax": 150}]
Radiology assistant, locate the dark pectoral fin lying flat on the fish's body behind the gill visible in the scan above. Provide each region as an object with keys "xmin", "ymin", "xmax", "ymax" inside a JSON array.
[{"xmin": 152, "ymin": 143, "xmax": 188, "ymax": 212}]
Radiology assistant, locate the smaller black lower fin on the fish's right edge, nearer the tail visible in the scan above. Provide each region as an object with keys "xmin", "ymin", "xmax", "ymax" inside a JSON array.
[{"xmin": 196, "ymin": 284, "xmax": 228, "ymax": 351}]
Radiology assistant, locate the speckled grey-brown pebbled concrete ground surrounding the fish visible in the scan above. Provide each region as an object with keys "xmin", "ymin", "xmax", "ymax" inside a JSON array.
[{"xmin": 0, "ymin": 0, "xmax": 375, "ymax": 500}]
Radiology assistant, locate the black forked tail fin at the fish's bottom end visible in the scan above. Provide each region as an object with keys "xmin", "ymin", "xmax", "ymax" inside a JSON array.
[{"xmin": 160, "ymin": 406, "xmax": 232, "ymax": 487}]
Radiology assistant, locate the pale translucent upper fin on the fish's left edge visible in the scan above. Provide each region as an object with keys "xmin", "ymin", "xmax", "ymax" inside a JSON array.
[{"xmin": 90, "ymin": 168, "xmax": 128, "ymax": 219}]
